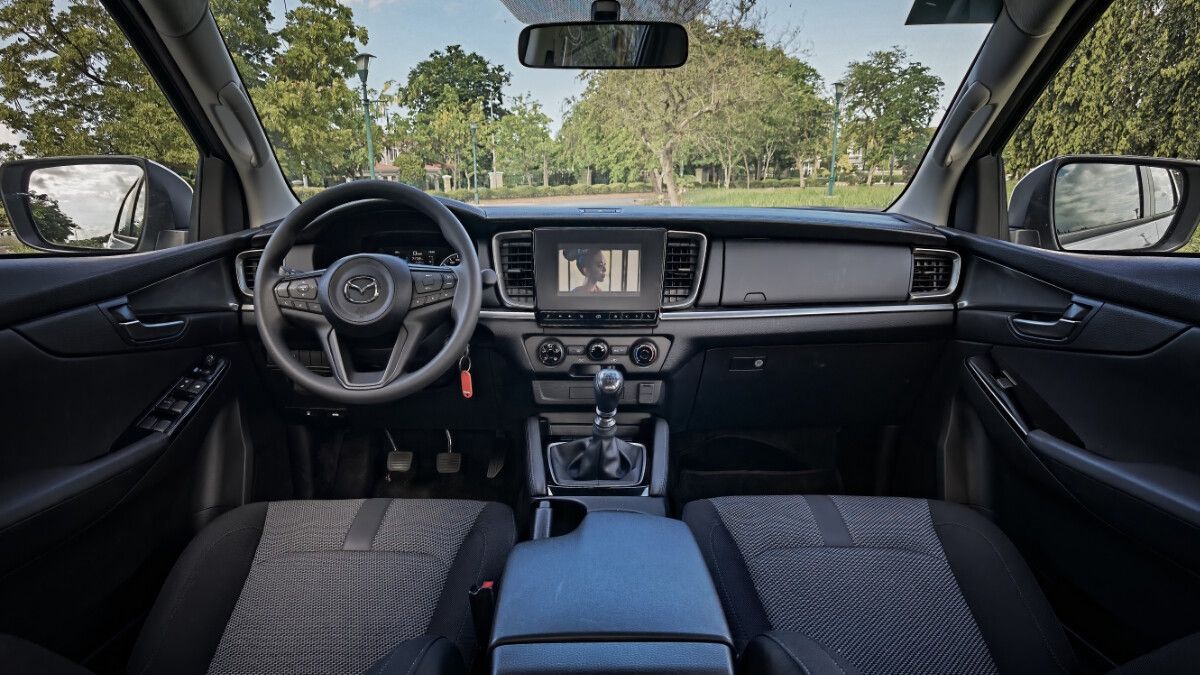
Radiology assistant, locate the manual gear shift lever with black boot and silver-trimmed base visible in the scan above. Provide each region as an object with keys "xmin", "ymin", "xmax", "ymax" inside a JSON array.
[{"xmin": 550, "ymin": 368, "xmax": 646, "ymax": 484}]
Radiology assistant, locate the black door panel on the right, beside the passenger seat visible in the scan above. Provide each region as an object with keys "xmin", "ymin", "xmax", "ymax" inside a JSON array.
[{"xmin": 947, "ymin": 234, "xmax": 1200, "ymax": 662}]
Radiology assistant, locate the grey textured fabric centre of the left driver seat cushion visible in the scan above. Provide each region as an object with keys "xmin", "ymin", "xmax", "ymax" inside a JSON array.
[{"xmin": 208, "ymin": 500, "xmax": 486, "ymax": 675}]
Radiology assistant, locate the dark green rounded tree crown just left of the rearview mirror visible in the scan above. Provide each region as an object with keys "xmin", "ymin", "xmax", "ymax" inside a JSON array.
[{"xmin": 402, "ymin": 44, "xmax": 512, "ymax": 119}]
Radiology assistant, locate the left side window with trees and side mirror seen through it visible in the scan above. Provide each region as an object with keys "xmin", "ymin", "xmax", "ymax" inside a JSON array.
[{"xmin": 0, "ymin": 0, "xmax": 199, "ymax": 256}]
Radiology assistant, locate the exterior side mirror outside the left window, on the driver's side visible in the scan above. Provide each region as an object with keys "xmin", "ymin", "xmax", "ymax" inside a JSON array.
[{"xmin": 0, "ymin": 156, "xmax": 192, "ymax": 253}]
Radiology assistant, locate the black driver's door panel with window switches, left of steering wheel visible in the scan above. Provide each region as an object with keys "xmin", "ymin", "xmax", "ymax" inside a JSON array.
[{"xmin": 0, "ymin": 238, "xmax": 246, "ymax": 659}]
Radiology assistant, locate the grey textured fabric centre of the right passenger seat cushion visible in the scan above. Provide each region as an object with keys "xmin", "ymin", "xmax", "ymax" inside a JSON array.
[{"xmin": 705, "ymin": 496, "xmax": 997, "ymax": 674}]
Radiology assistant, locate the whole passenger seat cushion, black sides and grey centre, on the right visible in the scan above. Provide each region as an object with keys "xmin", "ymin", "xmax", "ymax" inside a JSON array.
[{"xmin": 683, "ymin": 496, "xmax": 1079, "ymax": 674}]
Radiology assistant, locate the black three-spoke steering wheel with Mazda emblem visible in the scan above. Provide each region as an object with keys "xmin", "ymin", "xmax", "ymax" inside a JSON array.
[{"xmin": 254, "ymin": 180, "xmax": 482, "ymax": 404}]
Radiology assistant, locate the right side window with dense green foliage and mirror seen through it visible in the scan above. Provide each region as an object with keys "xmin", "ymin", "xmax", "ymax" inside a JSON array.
[{"xmin": 1003, "ymin": 0, "xmax": 1200, "ymax": 253}]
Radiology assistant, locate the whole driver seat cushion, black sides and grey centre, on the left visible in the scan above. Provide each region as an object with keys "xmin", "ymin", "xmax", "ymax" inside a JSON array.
[{"xmin": 128, "ymin": 500, "xmax": 516, "ymax": 675}]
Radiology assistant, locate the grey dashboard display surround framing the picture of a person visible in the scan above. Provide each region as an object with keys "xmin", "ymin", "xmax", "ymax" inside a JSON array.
[{"xmin": 533, "ymin": 227, "xmax": 667, "ymax": 310}]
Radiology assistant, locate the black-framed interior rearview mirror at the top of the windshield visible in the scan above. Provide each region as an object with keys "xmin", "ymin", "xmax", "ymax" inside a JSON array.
[{"xmin": 517, "ymin": 22, "xmax": 688, "ymax": 68}]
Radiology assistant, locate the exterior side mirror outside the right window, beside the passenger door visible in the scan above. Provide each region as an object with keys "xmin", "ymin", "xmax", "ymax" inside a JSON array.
[{"xmin": 1008, "ymin": 155, "xmax": 1200, "ymax": 252}]
